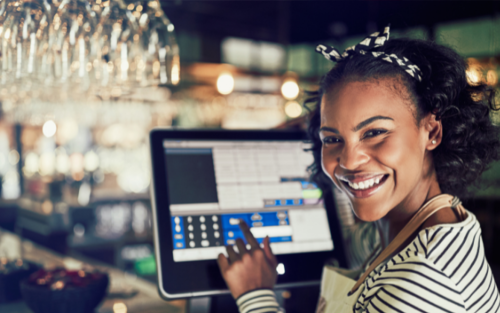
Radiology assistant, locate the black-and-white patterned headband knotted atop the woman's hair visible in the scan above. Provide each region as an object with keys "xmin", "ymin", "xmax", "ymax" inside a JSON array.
[{"xmin": 316, "ymin": 26, "xmax": 422, "ymax": 81}]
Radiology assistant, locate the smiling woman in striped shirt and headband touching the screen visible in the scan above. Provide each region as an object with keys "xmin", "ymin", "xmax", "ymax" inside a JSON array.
[{"xmin": 219, "ymin": 28, "xmax": 500, "ymax": 313}]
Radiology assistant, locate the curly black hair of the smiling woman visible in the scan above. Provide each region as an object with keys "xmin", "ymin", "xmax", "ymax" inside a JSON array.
[{"xmin": 304, "ymin": 38, "xmax": 500, "ymax": 196}]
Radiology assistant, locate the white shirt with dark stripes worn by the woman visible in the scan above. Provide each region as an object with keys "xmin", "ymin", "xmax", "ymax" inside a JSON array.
[{"xmin": 235, "ymin": 212, "xmax": 500, "ymax": 313}]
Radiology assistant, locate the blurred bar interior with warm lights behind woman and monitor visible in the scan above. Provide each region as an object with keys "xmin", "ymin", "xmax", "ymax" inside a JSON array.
[{"xmin": 0, "ymin": 0, "xmax": 500, "ymax": 310}]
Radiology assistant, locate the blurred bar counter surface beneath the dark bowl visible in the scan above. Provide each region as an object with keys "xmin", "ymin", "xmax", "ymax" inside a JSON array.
[{"xmin": 0, "ymin": 229, "xmax": 186, "ymax": 313}]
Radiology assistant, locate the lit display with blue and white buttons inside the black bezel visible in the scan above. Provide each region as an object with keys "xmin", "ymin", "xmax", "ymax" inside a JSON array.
[{"xmin": 163, "ymin": 140, "xmax": 334, "ymax": 262}]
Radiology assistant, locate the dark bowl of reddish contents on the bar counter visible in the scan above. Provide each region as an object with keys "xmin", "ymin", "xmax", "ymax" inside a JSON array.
[{"xmin": 21, "ymin": 268, "xmax": 109, "ymax": 313}]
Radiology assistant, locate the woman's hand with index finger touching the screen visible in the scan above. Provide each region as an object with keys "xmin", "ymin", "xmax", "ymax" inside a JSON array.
[{"xmin": 217, "ymin": 220, "xmax": 278, "ymax": 299}]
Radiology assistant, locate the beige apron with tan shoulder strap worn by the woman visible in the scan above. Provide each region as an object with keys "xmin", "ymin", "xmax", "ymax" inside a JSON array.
[{"xmin": 316, "ymin": 194, "xmax": 467, "ymax": 313}]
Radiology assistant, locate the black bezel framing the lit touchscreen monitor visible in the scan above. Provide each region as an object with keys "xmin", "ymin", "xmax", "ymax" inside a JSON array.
[{"xmin": 149, "ymin": 129, "xmax": 346, "ymax": 299}]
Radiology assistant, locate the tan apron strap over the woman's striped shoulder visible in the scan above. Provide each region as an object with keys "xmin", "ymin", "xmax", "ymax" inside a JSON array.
[{"xmin": 348, "ymin": 194, "xmax": 467, "ymax": 296}]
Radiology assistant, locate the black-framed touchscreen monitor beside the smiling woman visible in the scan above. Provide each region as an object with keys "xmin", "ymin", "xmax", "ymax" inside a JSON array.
[{"xmin": 151, "ymin": 130, "xmax": 343, "ymax": 299}]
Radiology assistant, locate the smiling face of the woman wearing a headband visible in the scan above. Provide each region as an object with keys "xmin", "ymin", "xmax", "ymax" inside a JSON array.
[{"xmin": 320, "ymin": 79, "xmax": 429, "ymax": 221}]
